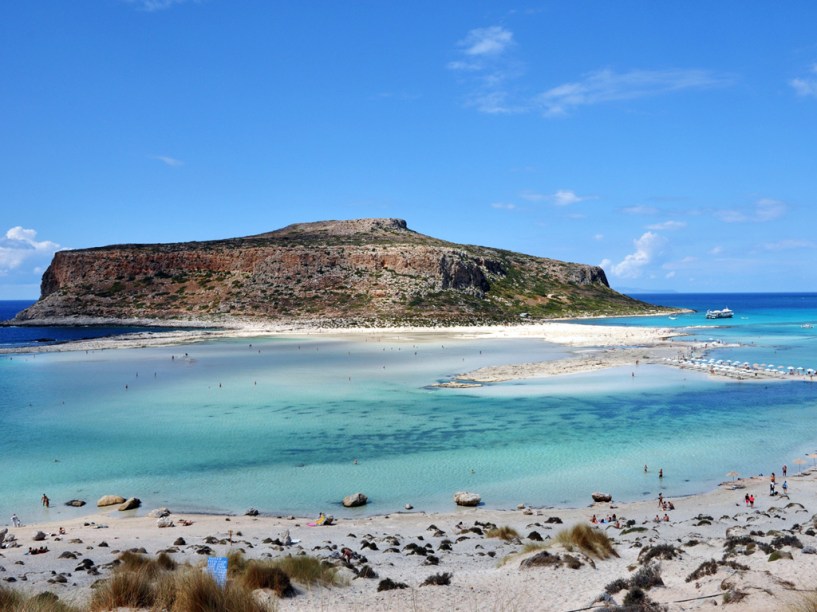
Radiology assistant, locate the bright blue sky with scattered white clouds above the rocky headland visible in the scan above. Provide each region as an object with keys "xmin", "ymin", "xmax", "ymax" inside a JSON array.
[{"xmin": 0, "ymin": 0, "xmax": 817, "ymax": 299}]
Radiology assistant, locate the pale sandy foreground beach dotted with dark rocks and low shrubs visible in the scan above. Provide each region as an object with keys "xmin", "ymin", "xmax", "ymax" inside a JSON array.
[{"xmin": 6, "ymin": 470, "xmax": 817, "ymax": 610}]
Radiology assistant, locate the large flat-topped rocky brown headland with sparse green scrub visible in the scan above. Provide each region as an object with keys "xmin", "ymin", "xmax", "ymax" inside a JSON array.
[{"xmin": 17, "ymin": 219, "xmax": 648, "ymax": 325}]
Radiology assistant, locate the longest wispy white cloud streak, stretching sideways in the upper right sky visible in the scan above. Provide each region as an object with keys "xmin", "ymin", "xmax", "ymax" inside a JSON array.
[{"xmin": 536, "ymin": 69, "xmax": 728, "ymax": 116}]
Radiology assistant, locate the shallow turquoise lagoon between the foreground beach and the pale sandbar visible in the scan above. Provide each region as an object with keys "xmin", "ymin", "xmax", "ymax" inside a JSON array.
[{"xmin": 0, "ymin": 294, "xmax": 817, "ymax": 522}]
